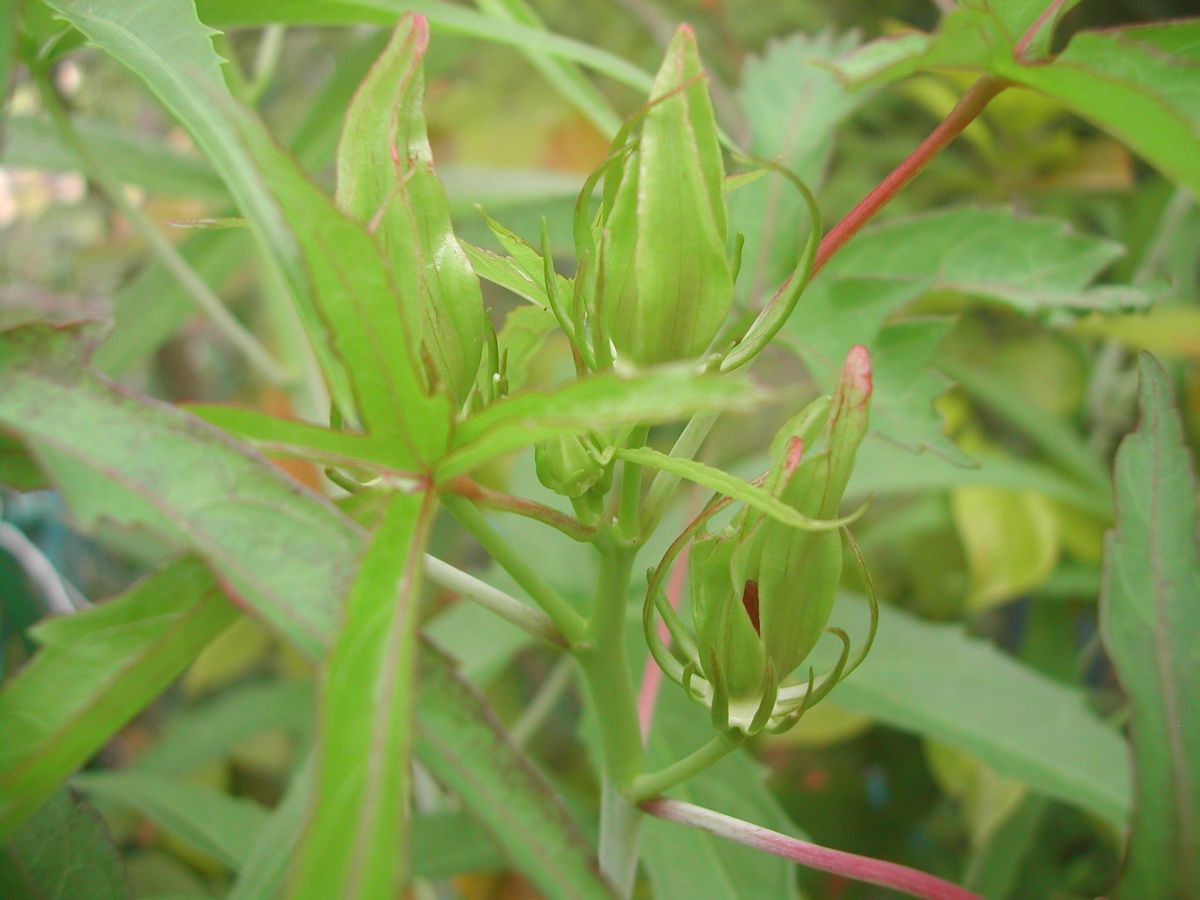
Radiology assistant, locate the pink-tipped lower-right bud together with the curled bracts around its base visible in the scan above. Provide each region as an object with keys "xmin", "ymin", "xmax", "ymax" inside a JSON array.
[{"xmin": 643, "ymin": 347, "xmax": 878, "ymax": 734}]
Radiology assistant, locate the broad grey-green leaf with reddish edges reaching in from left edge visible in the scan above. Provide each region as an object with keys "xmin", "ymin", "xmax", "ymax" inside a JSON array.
[{"xmin": 0, "ymin": 326, "xmax": 360, "ymax": 655}]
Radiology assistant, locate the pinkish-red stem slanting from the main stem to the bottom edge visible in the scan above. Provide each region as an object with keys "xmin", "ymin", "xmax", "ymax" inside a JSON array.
[{"xmin": 642, "ymin": 797, "xmax": 983, "ymax": 900}]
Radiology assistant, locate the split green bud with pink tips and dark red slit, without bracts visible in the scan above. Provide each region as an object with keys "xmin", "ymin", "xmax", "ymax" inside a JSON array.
[{"xmin": 690, "ymin": 347, "xmax": 871, "ymax": 728}]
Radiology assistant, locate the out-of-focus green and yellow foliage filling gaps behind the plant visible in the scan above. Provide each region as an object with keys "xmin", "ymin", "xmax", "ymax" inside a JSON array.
[{"xmin": 0, "ymin": 0, "xmax": 1200, "ymax": 898}]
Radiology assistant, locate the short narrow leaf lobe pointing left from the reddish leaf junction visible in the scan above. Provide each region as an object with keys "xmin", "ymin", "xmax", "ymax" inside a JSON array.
[{"xmin": 182, "ymin": 403, "xmax": 404, "ymax": 472}]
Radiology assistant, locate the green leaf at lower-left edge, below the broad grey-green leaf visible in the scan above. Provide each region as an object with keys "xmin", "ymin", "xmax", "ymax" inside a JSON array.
[{"xmin": 0, "ymin": 559, "xmax": 236, "ymax": 836}]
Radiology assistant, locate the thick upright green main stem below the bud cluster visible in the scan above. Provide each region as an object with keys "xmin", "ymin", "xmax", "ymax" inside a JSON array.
[{"xmin": 576, "ymin": 535, "xmax": 643, "ymax": 898}]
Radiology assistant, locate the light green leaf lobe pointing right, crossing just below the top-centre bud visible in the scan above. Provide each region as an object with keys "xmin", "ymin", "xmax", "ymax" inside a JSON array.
[{"xmin": 438, "ymin": 365, "xmax": 761, "ymax": 480}]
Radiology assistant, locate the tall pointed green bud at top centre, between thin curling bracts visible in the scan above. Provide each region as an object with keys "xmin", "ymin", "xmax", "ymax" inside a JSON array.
[{"xmin": 596, "ymin": 25, "xmax": 733, "ymax": 366}]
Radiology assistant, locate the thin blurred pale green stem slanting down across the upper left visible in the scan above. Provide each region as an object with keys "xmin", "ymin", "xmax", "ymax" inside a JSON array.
[{"xmin": 30, "ymin": 67, "xmax": 292, "ymax": 384}]
